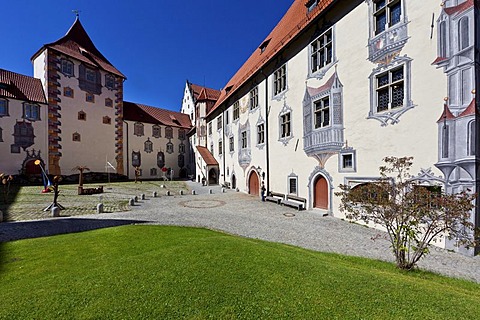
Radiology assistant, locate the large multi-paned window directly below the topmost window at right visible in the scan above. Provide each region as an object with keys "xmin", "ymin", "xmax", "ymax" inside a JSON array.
[{"xmin": 376, "ymin": 66, "xmax": 404, "ymax": 112}]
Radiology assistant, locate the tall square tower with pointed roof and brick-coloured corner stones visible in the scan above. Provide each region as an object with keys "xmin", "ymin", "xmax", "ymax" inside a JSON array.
[{"xmin": 31, "ymin": 16, "xmax": 126, "ymax": 174}]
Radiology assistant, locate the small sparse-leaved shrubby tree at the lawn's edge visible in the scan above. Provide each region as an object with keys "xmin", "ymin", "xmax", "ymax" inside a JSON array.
[{"xmin": 336, "ymin": 157, "xmax": 475, "ymax": 270}]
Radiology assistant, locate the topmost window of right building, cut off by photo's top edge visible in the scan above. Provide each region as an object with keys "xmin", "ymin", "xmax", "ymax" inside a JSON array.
[{"xmin": 373, "ymin": 0, "xmax": 402, "ymax": 35}]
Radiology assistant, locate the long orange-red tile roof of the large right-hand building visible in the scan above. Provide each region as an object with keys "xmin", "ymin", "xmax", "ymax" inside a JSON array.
[{"xmin": 210, "ymin": 0, "xmax": 334, "ymax": 112}]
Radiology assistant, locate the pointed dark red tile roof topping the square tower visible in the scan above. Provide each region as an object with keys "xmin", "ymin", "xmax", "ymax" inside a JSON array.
[{"xmin": 31, "ymin": 17, "xmax": 126, "ymax": 78}]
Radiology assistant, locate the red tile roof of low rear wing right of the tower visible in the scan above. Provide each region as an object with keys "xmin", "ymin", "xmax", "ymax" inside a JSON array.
[{"xmin": 123, "ymin": 101, "xmax": 192, "ymax": 129}]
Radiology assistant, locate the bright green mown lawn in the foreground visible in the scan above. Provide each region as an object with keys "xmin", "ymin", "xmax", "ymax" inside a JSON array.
[{"xmin": 0, "ymin": 226, "xmax": 480, "ymax": 319}]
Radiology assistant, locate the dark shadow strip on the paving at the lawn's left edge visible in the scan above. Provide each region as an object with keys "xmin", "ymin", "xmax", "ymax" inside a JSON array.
[{"xmin": 0, "ymin": 218, "xmax": 148, "ymax": 242}]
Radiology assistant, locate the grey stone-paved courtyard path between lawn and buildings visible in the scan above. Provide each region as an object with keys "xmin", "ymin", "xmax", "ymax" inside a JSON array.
[{"xmin": 0, "ymin": 183, "xmax": 480, "ymax": 283}]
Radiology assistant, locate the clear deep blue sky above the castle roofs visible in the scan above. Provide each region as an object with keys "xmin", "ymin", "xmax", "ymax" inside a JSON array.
[{"xmin": 0, "ymin": 0, "xmax": 293, "ymax": 111}]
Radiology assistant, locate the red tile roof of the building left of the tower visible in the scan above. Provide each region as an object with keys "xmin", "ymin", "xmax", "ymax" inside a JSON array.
[{"xmin": 0, "ymin": 69, "xmax": 47, "ymax": 104}]
